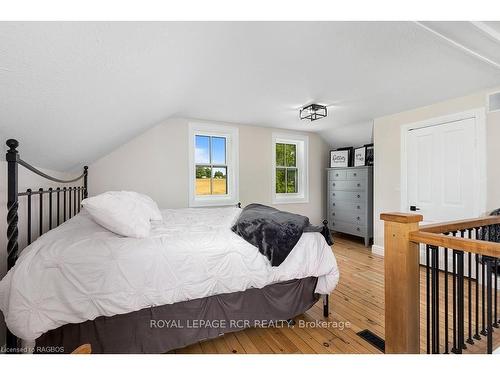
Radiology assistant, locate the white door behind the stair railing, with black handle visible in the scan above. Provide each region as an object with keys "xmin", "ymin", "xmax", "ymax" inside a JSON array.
[{"xmin": 407, "ymin": 118, "xmax": 478, "ymax": 223}]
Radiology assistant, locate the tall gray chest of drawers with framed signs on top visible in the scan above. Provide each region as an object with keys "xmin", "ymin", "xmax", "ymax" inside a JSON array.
[{"xmin": 327, "ymin": 167, "xmax": 373, "ymax": 246}]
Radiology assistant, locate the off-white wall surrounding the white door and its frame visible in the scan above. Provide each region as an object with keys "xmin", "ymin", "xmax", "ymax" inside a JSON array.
[{"xmin": 374, "ymin": 89, "xmax": 500, "ymax": 256}]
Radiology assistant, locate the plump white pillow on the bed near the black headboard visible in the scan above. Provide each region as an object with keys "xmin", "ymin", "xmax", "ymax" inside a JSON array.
[{"xmin": 82, "ymin": 191, "xmax": 151, "ymax": 238}]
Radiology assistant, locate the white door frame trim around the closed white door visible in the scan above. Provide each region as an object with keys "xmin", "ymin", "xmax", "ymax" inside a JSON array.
[{"xmin": 400, "ymin": 108, "xmax": 487, "ymax": 219}]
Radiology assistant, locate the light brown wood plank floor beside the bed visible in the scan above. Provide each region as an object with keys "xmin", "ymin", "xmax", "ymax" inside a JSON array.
[{"xmin": 172, "ymin": 236, "xmax": 500, "ymax": 354}]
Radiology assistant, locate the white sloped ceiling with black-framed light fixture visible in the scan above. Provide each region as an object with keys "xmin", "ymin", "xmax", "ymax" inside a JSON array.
[{"xmin": 0, "ymin": 22, "xmax": 500, "ymax": 170}]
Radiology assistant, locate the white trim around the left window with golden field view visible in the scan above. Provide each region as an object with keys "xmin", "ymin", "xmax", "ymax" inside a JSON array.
[{"xmin": 188, "ymin": 122, "xmax": 239, "ymax": 207}]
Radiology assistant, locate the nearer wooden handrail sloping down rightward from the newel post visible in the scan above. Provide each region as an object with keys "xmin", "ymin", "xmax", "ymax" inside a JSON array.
[{"xmin": 410, "ymin": 230, "xmax": 500, "ymax": 258}]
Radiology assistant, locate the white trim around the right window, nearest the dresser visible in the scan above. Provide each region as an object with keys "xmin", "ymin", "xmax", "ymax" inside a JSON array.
[{"xmin": 271, "ymin": 132, "xmax": 309, "ymax": 204}]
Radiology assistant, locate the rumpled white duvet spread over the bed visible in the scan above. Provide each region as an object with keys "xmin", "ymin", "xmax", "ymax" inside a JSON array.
[{"xmin": 0, "ymin": 207, "xmax": 339, "ymax": 340}]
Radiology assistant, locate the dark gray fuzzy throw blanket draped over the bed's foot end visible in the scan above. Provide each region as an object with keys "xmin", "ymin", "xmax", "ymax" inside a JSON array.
[{"xmin": 231, "ymin": 203, "xmax": 333, "ymax": 267}]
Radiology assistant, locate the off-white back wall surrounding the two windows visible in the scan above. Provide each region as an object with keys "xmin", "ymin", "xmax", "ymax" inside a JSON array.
[{"xmin": 89, "ymin": 119, "xmax": 329, "ymax": 224}]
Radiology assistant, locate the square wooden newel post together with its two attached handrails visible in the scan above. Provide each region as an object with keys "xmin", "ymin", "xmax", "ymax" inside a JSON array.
[{"xmin": 380, "ymin": 212, "xmax": 500, "ymax": 353}]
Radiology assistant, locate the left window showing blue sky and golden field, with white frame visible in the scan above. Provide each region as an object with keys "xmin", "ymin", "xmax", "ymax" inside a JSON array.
[{"xmin": 189, "ymin": 123, "xmax": 238, "ymax": 207}]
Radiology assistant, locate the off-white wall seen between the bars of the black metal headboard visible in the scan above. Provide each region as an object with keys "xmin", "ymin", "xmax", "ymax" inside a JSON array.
[{"xmin": 0, "ymin": 160, "xmax": 73, "ymax": 346}]
